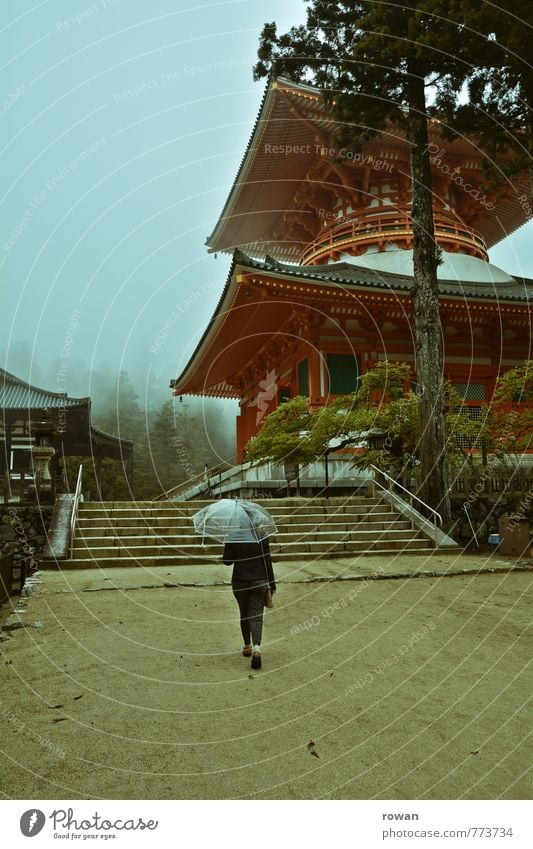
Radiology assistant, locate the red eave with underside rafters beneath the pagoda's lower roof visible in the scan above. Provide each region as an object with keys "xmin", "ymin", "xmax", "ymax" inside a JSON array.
[{"xmin": 173, "ymin": 254, "xmax": 531, "ymax": 408}]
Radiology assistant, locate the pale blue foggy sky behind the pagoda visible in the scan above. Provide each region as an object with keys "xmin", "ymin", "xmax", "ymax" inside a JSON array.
[{"xmin": 0, "ymin": 0, "xmax": 533, "ymax": 397}]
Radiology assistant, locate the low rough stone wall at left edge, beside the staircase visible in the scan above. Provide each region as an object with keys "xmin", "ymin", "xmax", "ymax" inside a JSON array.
[{"xmin": 0, "ymin": 504, "xmax": 53, "ymax": 579}]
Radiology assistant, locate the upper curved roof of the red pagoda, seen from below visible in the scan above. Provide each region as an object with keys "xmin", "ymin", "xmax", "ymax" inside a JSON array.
[{"xmin": 206, "ymin": 78, "xmax": 530, "ymax": 262}]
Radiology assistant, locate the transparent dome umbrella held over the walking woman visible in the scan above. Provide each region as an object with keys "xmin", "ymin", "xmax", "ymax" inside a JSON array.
[{"xmin": 192, "ymin": 498, "xmax": 278, "ymax": 542}]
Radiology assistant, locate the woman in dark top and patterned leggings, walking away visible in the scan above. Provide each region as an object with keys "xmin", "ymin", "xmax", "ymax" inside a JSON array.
[{"xmin": 222, "ymin": 531, "xmax": 276, "ymax": 669}]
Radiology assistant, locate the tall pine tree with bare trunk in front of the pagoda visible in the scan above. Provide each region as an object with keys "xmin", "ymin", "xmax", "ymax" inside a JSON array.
[{"xmin": 254, "ymin": 0, "xmax": 474, "ymax": 525}]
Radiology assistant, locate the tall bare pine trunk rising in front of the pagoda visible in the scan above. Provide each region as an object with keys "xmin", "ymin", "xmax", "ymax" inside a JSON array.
[{"xmin": 407, "ymin": 61, "xmax": 451, "ymax": 527}]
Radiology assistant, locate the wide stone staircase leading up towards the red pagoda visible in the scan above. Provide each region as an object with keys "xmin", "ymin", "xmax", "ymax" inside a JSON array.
[{"xmin": 61, "ymin": 496, "xmax": 442, "ymax": 568}]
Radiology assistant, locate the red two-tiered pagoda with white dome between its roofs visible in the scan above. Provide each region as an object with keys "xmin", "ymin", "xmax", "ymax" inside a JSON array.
[{"xmin": 171, "ymin": 78, "xmax": 533, "ymax": 462}]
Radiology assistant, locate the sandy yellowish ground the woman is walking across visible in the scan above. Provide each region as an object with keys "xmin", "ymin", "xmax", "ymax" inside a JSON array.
[{"xmin": 0, "ymin": 555, "xmax": 533, "ymax": 799}]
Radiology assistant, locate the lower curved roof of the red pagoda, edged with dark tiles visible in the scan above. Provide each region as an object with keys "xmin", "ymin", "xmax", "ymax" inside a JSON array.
[{"xmin": 170, "ymin": 251, "xmax": 533, "ymax": 398}]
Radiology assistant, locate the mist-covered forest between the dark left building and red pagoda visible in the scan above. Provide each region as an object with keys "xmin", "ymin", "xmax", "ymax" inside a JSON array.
[{"xmin": 2, "ymin": 342, "xmax": 235, "ymax": 501}]
